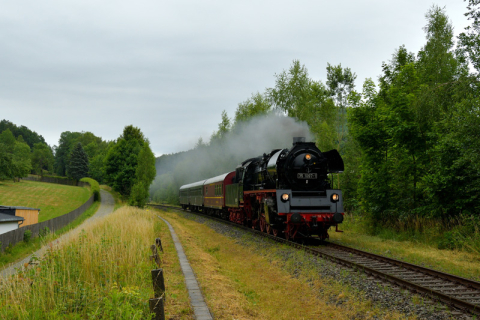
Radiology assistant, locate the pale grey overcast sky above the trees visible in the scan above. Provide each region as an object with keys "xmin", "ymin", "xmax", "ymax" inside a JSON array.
[{"xmin": 0, "ymin": 0, "xmax": 468, "ymax": 156}]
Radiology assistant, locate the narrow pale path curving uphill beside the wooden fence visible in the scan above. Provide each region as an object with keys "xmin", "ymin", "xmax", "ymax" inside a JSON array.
[{"xmin": 0, "ymin": 190, "xmax": 115, "ymax": 277}]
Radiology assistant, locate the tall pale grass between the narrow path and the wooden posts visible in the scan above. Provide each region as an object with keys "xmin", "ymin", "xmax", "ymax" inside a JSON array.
[{"xmin": 0, "ymin": 207, "xmax": 159, "ymax": 319}]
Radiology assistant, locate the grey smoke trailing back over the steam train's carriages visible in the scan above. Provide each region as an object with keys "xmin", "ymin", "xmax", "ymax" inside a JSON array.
[{"xmin": 150, "ymin": 113, "xmax": 313, "ymax": 202}]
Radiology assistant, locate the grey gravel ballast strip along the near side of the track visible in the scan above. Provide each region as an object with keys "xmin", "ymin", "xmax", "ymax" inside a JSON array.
[{"xmin": 172, "ymin": 212, "xmax": 473, "ymax": 320}]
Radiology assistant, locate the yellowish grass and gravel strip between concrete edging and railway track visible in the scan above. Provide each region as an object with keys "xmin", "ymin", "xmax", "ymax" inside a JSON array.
[{"xmin": 154, "ymin": 208, "xmax": 458, "ymax": 319}]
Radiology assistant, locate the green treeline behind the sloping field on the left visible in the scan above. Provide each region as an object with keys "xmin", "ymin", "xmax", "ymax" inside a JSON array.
[{"xmin": 0, "ymin": 120, "xmax": 155, "ymax": 207}]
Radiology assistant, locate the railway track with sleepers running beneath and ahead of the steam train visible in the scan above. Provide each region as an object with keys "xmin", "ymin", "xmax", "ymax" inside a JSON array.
[{"xmin": 150, "ymin": 204, "xmax": 480, "ymax": 316}]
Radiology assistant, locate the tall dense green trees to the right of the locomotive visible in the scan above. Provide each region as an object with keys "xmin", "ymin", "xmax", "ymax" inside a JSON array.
[{"xmin": 349, "ymin": 6, "xmax": 480, "ymax": 228}]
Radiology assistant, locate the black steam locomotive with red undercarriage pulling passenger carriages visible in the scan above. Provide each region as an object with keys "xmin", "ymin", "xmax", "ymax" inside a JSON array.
[{"xmin": 179, "ymin": 137, "xmax": 344, "ymax": 240}]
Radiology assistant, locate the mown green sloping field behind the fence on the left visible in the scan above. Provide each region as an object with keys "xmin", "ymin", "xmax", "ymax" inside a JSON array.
[{"xmin": 0, "ymin": 181, "xmax": 90, "ymax": 222}]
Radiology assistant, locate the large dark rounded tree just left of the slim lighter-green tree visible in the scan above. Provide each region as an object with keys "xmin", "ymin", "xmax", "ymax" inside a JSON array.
[{"xmin": 105, "ymin": 125, "xmax": 145, "ymax": 198}]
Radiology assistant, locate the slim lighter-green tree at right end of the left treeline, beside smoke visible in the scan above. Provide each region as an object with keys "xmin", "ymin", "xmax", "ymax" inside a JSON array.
[{"xmin": 130, "ymin": 141, "xmax": 156, "ymax": 208}]
